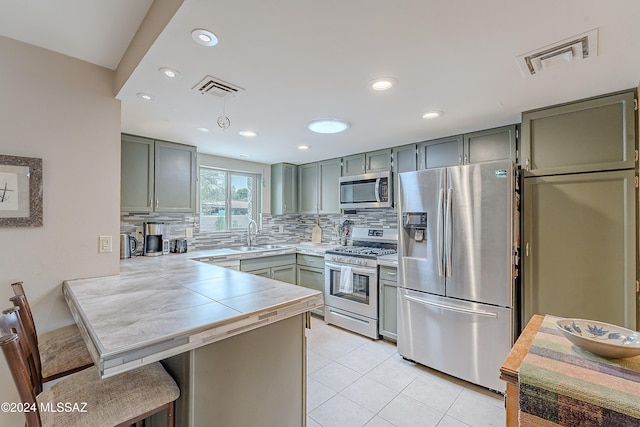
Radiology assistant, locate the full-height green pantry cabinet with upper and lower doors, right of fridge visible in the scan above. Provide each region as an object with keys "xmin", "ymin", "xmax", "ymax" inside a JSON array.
[{"xmin": 520, "ymin": 90, "xmax": 638, "ymax": 329}]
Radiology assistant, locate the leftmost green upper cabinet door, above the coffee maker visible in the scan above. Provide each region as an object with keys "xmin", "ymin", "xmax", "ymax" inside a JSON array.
[{"xmin": 120, "ymin": 135, "xmax": 155, "ymax": 212}]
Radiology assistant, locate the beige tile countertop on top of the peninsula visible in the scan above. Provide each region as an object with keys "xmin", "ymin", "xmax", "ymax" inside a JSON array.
[{"xmin": 63, "ymin": 252, "xmax": 324, "ymax": 378}]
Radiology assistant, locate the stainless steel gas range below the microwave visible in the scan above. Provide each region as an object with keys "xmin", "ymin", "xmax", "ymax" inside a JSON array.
[{"xmin": 324, "ymin": 227, "xmax": 398, "ymax": 339}]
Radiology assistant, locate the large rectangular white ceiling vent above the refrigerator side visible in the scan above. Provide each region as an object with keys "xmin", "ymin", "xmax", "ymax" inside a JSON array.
[{"xmin": 516, "ymin": 29, "xmax": 598, "ymax": 77}]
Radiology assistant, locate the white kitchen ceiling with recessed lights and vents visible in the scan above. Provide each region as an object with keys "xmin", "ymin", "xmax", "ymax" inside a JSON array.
[{"xmin": 0, "ymin": 0, "xmax": 640, "ymax": 163}]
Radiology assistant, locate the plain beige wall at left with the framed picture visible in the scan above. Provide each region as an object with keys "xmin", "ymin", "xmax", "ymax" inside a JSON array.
[{"xmin": 0, "ymin": 37, "xmax": 121, "ymax": 426}]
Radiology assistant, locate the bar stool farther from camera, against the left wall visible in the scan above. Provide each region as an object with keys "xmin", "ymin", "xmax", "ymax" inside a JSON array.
[{"xmin": 10, "ymin": 282, "xmax": 93, "ymax": 383}]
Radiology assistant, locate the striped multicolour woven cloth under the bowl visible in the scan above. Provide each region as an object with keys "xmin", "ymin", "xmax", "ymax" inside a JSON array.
[{"xmin": 518, "ymin": 315, "xmax": 640, "ymax": 427}]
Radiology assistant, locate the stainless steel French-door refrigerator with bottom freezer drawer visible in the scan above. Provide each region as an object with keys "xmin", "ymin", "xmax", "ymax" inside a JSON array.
[{"xmin": 398, "ymin": 161, "xmax": 519, "ymax": 392}]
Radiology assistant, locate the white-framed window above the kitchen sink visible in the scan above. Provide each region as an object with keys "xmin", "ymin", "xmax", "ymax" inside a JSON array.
[{"xmin": 200, "ymin": 166, "xmax": 260, "ymax": 231}]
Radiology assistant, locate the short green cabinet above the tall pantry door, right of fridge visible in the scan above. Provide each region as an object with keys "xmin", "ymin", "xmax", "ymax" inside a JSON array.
[{"xmin": 520, "ymin": 90, "xmax": 636, "ymax": 176}]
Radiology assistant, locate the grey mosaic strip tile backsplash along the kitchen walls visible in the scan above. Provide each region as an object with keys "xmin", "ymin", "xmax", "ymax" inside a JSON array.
[{"xmin": 120, "ymin": 209, "xmax": 398, "ymax": 250}]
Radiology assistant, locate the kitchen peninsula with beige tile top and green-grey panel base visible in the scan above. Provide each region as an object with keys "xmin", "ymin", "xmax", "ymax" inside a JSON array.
[{"xmin": 63, "ymin": 254, "xmax": 323, "ymax": 426}]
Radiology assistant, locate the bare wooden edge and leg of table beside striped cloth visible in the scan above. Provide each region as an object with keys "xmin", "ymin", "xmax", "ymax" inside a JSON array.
[{"xmin": 500, "ymin": 314, "xmax": 544, "ymax": 427}]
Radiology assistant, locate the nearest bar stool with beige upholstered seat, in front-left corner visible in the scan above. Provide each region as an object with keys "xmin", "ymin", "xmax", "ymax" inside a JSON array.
[{"xmin": 0, "ymin": 308, "xmax": 180, "ymax": 427}]
